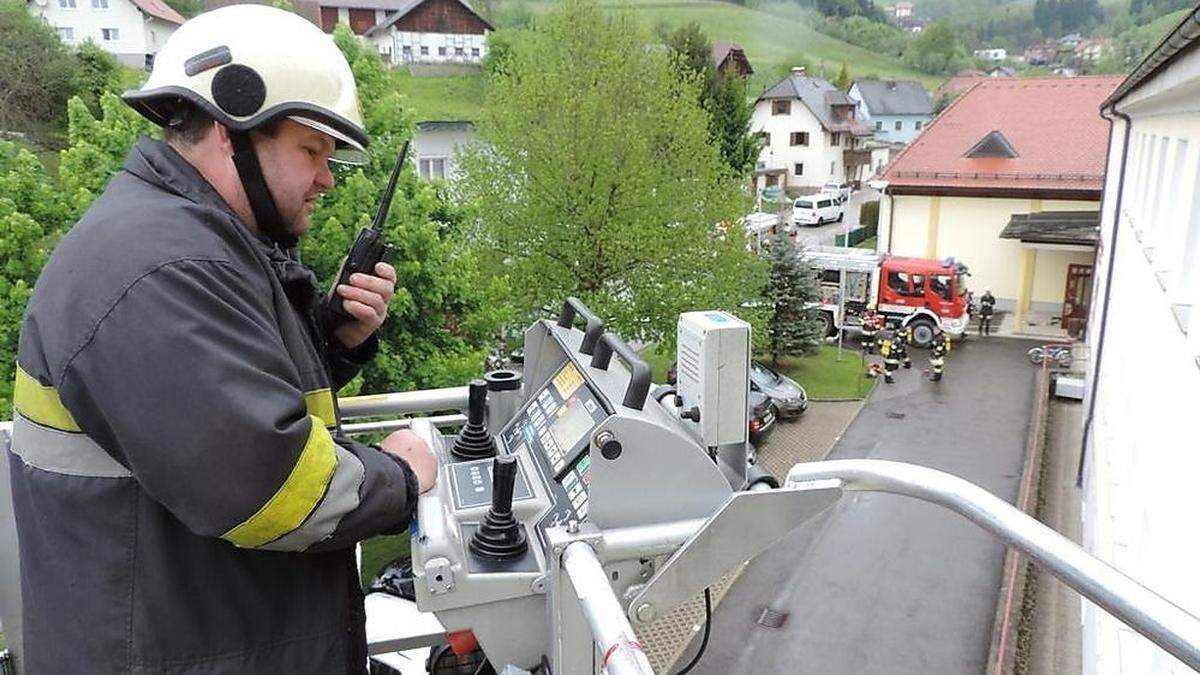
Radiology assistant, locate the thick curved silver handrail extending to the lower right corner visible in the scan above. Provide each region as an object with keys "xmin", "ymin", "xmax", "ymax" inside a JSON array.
[{"xmin": 787, "ymin": 460, "xmax": 1200, "ymax": 670}]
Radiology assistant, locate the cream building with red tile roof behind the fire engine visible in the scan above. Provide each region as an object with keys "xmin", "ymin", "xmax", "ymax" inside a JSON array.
[{"xmin": 878, "ymin": 77, "xmax": 1120, "ymax": 336}]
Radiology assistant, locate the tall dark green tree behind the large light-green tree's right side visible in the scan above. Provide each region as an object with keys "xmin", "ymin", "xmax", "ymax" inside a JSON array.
[{"xmin": 666, "ymin": 22, "xmax": 758, "ymax": 175}]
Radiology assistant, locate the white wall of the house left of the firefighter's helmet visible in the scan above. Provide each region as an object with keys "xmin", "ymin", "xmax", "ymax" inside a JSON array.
[{"xmin": 26, "ymin": 0, "xmax": 161, "ymax": 67}]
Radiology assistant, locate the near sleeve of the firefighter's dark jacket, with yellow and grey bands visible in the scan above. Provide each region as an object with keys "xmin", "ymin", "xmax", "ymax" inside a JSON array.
[{"xmin": 59, "ymin": 261, "xmax": 416, "ymax": 551}]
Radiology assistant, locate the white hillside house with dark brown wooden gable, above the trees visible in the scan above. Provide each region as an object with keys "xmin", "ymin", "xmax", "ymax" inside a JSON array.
[{"xmin": 357, "ymin": 0, "xmax": 494, "ymax": 65}]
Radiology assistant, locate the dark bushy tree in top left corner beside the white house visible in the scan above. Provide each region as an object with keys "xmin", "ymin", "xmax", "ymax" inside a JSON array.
[{"xmin": 0, "ymin": 0, "xmax": 78, "ymax": 136}]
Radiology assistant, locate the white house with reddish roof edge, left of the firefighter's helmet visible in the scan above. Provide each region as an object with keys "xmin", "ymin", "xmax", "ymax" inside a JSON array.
[{"xmin": 25, "ymin": 0, "xmax": 184, "ymax": 68}]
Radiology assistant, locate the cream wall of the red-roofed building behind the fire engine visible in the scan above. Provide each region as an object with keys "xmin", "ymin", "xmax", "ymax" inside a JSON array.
[{"xmin": 878, "ymin": 196, "xmax": 1099, "ymax": 312}]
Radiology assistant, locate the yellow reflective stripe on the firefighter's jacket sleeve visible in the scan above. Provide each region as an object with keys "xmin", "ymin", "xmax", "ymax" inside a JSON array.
[{"xmin": 222, "ymin": 416, "xmax": 337, "ymax": 549}]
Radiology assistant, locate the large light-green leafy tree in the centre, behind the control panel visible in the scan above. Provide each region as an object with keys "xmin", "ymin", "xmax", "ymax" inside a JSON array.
[{"xmin": 462, "ymin": 0, "xmax": 764, "ymax": 348}]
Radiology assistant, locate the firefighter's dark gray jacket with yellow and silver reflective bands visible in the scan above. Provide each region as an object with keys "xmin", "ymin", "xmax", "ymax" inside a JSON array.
[{"xmin": 8, "ymin": 139, "xmax": 416, "ymax": 675}]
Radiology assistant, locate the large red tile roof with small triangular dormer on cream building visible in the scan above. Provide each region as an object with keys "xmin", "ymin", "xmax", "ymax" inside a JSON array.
[{"xmin": 882, "ymin": 76, "xmax": 1122, "ymax": 193}]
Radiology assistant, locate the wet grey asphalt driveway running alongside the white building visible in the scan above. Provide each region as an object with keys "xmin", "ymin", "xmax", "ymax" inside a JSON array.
[{"xmin": 695, "ymin": 339, "xmax": 1034, "ymax": 675}]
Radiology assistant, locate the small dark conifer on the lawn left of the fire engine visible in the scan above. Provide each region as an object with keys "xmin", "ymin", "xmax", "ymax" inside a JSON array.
[{"xmin": 763, "ymin": 232, "xmax": 822, "ymax": 365}]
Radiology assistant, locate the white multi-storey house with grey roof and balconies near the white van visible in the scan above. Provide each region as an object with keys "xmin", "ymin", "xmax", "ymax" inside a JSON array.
[{"xmin": 750, "ymin": 68, "xmax": 871, "ymax": 191}]
